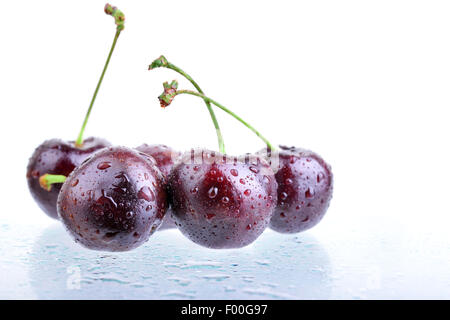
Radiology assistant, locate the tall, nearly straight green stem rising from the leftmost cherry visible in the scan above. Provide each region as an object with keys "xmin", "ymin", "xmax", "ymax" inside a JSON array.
[{"xmin": 75, "ymin": 4, "xmax": 125, "ymax": 147}]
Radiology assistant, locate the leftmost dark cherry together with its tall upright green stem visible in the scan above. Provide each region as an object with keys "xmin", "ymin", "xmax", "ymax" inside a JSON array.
[{"xmin": 27, "ymin": 4, "xmax": 125, "ymax": 219}]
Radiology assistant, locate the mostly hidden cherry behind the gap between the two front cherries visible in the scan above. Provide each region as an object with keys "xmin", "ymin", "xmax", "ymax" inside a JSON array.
[{"xmin": 136, "ymin": 143, "xmax": 181, "ymax": 230}]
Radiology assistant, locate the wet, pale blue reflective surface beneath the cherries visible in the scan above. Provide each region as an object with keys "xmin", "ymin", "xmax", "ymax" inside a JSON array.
[{"xmin": 0, "ymin": 218, "xmax": 450, "ymax": 299}]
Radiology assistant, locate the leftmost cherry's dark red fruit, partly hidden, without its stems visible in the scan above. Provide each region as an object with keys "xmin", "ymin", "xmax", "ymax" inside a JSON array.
[{"xmin": 27, "ymin": 137, "xmax": 110, "ymax": 219}]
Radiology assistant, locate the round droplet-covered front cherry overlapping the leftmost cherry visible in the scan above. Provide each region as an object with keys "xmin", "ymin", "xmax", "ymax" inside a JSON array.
[{"xmin": 58, "ymin": 147, "xmax": 167, "ymax": 251}]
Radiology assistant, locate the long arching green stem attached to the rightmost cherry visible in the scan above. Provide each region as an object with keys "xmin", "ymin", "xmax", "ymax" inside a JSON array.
[{"xmin": 158, "ymin": 80, "xmax": 275, "ymax": 150}]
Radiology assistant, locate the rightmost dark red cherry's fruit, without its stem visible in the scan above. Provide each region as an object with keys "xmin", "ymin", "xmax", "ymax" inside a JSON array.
[{"xmin": 259, "ymin": 146, "xmax": 333, "ymax": 233}]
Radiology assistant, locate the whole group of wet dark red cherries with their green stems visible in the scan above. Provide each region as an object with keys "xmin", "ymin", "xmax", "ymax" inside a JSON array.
[{"xmin": 27, "ymin": 4, "xmax": 333, "ymax": 251}]
